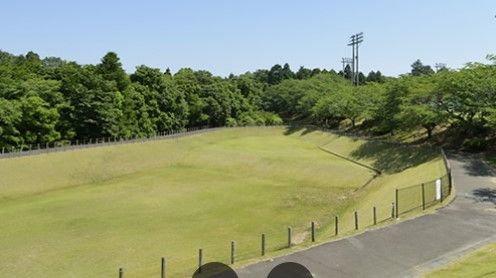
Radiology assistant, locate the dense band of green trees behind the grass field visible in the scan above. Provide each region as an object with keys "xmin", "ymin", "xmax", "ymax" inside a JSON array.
[{"xmin": 0, "ymin": 51, "xmax": 496, "ymax": 150}]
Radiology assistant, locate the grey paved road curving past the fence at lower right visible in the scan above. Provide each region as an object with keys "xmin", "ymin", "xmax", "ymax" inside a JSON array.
[{"xmin": 237, "ymin": 155, "xmax": 496, "ymax": 278}]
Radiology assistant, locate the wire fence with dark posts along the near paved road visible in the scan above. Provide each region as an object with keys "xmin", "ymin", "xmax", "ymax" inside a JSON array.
[{"xmin": 119, "ymin": 173, "xmax": 452, "ymax": 277}]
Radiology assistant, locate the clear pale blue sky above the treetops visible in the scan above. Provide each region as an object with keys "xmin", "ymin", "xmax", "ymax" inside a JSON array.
[{"xmin": 0, "ymin": 0, "xmax": 496, "ymax": 75}]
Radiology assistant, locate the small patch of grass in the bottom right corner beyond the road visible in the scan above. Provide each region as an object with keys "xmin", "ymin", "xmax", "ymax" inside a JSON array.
[{"xmin": 425, "ymin": 243, "xmax": 496, "ymax": 278}]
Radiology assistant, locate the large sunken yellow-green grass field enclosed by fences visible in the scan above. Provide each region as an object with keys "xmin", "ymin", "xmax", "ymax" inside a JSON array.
[{"xmin": 0, "ymin": 127, "xmax": 444, "ymax": 277}]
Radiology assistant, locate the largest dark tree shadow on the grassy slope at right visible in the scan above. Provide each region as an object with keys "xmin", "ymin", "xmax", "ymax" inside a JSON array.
[{"xmin": 351, "ymin": 141, "xmax": 439, "ymax": 174}]
